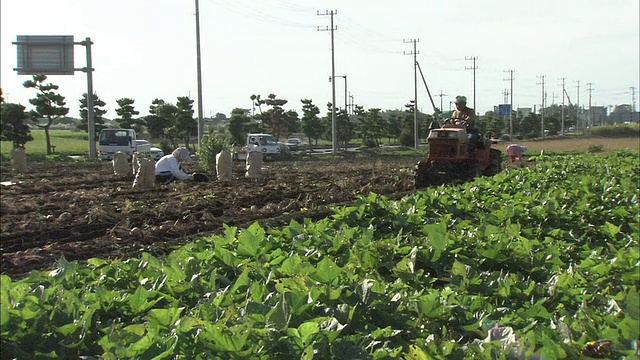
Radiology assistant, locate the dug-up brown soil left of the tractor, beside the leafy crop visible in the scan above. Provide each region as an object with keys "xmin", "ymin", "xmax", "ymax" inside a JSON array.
[{"xmin": 0, "ymin": 156, "xmax": 419, "ymax": 279}]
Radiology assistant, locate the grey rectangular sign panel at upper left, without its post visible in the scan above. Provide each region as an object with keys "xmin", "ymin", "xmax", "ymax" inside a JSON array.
[{"xmin": 14, "ymin": 35, "xmax": 75, "ymax": 75}]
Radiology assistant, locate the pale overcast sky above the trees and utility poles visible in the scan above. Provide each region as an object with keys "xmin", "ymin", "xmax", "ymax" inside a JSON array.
[{"xmin": 0, "ymin": 0, "xmax": 640, "ymax": 118}]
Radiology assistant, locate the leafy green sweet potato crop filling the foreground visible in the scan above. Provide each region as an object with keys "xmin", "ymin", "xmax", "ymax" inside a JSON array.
[{"xmin": 0, "ymin": 152, "xmax": 640, "ymax": 359}]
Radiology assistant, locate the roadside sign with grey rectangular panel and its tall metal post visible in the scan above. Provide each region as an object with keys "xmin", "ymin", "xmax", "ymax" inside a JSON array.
[{"xmin": 13, "ymin": 35, "xmax": 97, "ymax": 159}]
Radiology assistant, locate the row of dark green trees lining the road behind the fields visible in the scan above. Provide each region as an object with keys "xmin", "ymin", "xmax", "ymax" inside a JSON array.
[{"xmin": 1, "ymin": 75, "xmax": 592, "ymax": 154}]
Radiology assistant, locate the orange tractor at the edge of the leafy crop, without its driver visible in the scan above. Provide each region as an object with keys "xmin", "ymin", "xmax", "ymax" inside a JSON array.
[{"xmin": 415, "ymin": 124, "xmax": 502, "ymax": 188}]
